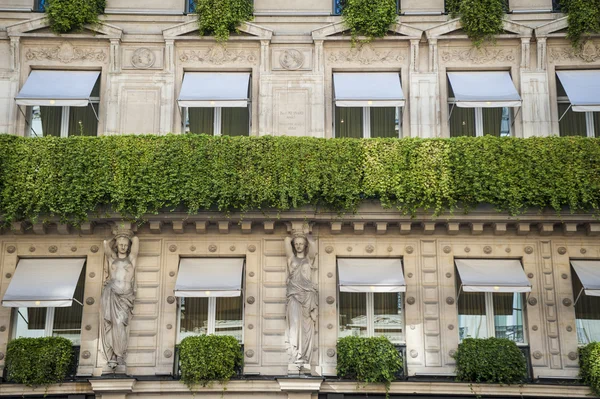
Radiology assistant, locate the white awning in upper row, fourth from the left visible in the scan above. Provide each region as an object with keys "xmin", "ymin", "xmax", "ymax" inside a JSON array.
[{"xmin": 448, "ymin": 72, "xmax": 521, "ymax": 108}]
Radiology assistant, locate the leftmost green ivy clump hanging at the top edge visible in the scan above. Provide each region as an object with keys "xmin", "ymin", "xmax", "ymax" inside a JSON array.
[{"xmin": 46, "ymin": 0, "xmax": 106, "ymax": 34}]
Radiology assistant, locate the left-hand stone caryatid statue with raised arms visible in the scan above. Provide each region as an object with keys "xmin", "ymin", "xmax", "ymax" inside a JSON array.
[{"xmin": 101, "ymin": 228, "xmax": 140, "ymax": 372}]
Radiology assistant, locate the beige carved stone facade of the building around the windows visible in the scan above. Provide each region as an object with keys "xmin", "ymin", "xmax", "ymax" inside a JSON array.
[{"xmin": 0, "ymin": 0, "xmax": 600, "ymax": 399}]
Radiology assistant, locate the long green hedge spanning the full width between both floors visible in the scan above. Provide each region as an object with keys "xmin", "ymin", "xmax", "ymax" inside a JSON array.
[{"xmin": 0, "ymin": 135, "xmax": 600, "ymax": 224}]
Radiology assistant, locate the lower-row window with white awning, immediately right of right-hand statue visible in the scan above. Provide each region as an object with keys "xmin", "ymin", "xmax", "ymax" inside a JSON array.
[{"xmin": 338, "ymin": 259, "xmax": 406, "ymax": 344}]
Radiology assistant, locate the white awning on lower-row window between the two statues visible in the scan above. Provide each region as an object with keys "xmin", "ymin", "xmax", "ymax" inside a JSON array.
[{"xmin": 175, "ymin": 258, "xmax": 244, "ymax": 297}]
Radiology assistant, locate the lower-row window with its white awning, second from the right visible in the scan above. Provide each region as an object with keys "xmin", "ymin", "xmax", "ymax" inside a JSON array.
[{"xmin": 456, "ymin": 259, "xmax": 531, "ymax": 344}]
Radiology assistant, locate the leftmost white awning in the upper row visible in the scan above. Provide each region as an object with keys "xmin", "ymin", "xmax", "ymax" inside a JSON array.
[{"xmin": 15, "ymin": 71, "xmax": 100, "ymax": 107}]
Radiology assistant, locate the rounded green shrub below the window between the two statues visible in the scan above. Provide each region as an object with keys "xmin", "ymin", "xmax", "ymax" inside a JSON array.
[{"xmin": 179, "ymin": 335, "xmax": 242, "ymax": 389}]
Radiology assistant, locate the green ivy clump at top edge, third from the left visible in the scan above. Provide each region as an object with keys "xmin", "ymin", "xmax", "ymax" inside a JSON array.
[{"xmin": 342, "ymin": 0, "xmax": 397, "ymax": 45}]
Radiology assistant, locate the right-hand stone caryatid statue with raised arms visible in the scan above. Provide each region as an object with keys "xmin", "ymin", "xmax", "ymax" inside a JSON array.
[{"xmin": 285, "ymin": 231, "xmax": 319, "ymax": 369}]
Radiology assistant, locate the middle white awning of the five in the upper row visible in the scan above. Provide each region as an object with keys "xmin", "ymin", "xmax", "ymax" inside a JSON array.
[{"xmin": 333, "ymin": 72, "xmax": 405, "ymax": 107}]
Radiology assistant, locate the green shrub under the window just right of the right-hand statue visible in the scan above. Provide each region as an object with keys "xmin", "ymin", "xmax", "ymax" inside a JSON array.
[{"xmin": 337, "ymin": 337, "xmax": 402, "ymax": 397}]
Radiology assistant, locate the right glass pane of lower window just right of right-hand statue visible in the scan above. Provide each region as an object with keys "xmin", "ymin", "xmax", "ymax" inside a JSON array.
[{"xmin": 373, "ymin": 292, "xmax": 404, "ymax": 344}]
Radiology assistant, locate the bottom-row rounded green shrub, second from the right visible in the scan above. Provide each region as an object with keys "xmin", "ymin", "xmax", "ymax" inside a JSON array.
[{"xmin": 454, "ymin": 338, "xmax": 527, "ymax": 384}]
